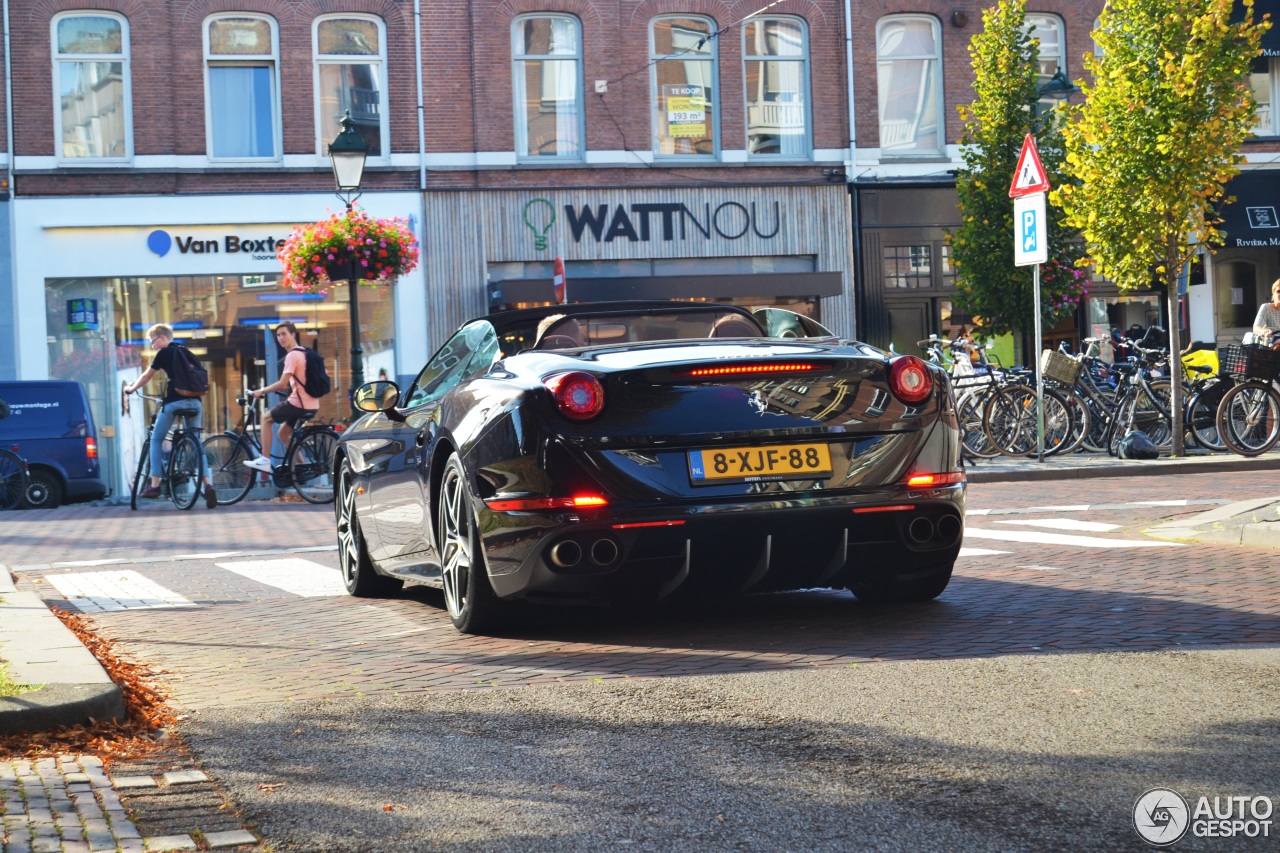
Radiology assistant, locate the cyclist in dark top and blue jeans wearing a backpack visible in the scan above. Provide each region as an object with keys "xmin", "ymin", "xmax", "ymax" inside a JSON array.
[{"xmin": 124, "ymin": 323, "xmax": 218, "ymax": 510}]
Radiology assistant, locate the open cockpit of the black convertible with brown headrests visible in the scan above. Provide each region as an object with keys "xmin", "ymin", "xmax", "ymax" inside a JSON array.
[{"xmin": 502, "ymin": 309, "xmax": 764, "ymax": 355}]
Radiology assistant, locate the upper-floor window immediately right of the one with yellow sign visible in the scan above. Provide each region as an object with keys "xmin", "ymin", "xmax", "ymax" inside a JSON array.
[{"xmin": 742, "ymin": 18, "xmax": 812, "ymax": 158}]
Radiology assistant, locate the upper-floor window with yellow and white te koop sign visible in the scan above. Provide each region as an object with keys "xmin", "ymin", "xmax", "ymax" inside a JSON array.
[{"xmin": 649, "ymin": 17, "xmax": 717, "ymax": 158}]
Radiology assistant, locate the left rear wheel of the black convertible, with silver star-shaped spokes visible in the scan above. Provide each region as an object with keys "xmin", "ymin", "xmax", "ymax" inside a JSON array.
[{"xmin": 436, "ymin": 453, "xmax": 506, "ymax": 634}]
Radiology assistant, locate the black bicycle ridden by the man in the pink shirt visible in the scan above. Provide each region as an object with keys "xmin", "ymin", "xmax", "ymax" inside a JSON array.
[{"xmin": 205, "ymin": 397, "xmax": 338, "ymax": 506}]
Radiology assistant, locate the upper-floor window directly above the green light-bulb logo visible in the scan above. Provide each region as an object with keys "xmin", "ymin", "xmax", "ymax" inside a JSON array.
[{"xmin": 511, "ymin": 15, "xmax": 584, "ymax": 159}]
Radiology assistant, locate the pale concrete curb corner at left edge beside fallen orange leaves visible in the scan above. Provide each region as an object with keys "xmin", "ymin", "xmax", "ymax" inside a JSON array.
[{"xmin": 0, "ymin": 565, "xmax": 124, "ymax": 734}]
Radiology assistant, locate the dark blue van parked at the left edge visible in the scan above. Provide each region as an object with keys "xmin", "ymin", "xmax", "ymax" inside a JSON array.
[{"xmin": 0, "ymin": 382, "xmax": 106, "ymax": 508}]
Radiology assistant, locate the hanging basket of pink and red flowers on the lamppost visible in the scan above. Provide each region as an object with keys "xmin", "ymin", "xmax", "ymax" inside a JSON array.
[{"xmin": 276, "ymin": 207, "xmax": 419, "ymax": 293}]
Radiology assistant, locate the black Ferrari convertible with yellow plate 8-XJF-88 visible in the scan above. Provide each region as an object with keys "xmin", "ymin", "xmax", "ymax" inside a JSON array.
[{"xmin": 333, "ymin": 302, "xmax": 965, "ymax": 633}]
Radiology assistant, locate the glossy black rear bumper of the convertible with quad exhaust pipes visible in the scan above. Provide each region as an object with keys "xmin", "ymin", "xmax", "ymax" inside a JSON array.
[{"xmin": 481, "ymin": 485, "xmax": 964, "ymax": 602}]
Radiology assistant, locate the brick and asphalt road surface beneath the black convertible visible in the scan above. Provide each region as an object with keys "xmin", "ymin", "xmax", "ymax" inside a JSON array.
[{"xmin": 13, "ymin": 473, "xmax": 1280, "ymax": 852}]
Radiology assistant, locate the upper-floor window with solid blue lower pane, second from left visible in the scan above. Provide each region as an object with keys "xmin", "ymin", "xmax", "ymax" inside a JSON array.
[{"xmin": 205, "ymin": 14, "xmax": 280, "ymax": 160}]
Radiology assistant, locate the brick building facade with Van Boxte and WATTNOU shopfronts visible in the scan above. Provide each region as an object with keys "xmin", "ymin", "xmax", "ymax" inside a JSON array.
[{"xmin": 0, "ymin": 0, "xmax": 1280, "ymax": 492}]
